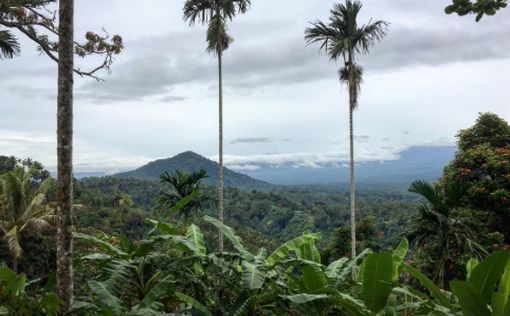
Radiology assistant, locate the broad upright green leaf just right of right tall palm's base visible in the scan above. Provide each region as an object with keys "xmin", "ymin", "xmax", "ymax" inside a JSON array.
[{"xmin": 362, "ymin": 252, "xmax": 393, "ymax": 313}]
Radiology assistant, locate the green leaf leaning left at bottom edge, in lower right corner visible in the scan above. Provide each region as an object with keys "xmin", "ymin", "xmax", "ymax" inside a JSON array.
[{"xmin": 450, "ymin": 280, "xmax": 491, "ymax": 316}]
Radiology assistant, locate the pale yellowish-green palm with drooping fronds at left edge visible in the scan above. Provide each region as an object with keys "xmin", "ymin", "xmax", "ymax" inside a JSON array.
[{"xmin": 0, "ymin": 167, "xmax": 56, "ymax": 271}]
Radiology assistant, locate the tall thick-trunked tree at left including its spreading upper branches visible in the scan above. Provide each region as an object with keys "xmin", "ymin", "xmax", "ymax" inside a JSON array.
[{"xmin": 0, "ymin": 0, "xmax": 124, "ymax": 311}]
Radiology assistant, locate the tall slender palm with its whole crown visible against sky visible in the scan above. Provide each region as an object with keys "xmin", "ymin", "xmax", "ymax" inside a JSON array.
[{"xmin": 305, "ymin": 0, "xmax": 388, "ymax": 257}]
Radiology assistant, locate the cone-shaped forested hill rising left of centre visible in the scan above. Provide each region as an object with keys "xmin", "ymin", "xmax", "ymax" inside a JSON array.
[{"xmin": 114, "ymin": 151, "xmax": 274, "ymax": 190}]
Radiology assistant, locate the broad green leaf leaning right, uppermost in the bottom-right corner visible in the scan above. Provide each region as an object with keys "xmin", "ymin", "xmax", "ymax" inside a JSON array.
[{"xmin": 468, "ymin": 251, "xmax": 508, "ymax": 302}]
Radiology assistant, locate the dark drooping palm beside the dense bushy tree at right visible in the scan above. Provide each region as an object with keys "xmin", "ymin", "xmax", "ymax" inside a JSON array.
[{"xmin": 407, "ymin": 181, "xmax": 486, "ymax": 288}]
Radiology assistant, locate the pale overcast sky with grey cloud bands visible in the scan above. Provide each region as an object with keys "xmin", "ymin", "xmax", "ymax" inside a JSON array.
[{"xmin": 0, "ymin": 0, "xmax": 510, "ymax": 173}]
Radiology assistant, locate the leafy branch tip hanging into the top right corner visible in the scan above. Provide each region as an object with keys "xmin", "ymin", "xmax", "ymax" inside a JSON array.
[{"xmin": 445, "ymin": 0, "xmax": 507, "ymax": 22}]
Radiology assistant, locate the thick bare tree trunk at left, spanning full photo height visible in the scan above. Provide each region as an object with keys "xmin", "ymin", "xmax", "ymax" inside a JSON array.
[{"xmin": 57, "ymin": 0, "xmax": 74, "ymax": 313}]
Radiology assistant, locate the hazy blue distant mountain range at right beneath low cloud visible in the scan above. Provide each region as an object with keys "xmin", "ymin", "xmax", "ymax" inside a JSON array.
[{"xmin": 237, "ymin": 146, "xmax": 456, "ymax": 185}]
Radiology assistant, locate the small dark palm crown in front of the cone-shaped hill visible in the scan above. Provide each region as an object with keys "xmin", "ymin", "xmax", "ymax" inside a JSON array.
[{"xmin": 156, "ymin": 169, "xmax": 211, "ymax": 222}]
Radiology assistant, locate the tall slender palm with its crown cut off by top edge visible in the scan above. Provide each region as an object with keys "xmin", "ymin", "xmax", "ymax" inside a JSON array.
[{"xmin": 183, "ymin": 0, "xmax": 251, "ymax": 251}]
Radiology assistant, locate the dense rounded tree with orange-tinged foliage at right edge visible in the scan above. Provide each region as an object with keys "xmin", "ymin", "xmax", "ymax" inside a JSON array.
[{"xmin": 441, "ymin": 113, "xmax": 510, "ymax": 243}]
